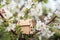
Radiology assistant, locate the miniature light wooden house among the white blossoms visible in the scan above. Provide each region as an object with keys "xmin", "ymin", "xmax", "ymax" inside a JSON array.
[{"xmin": 18, "ymin": 19, "xmax": 35, "ymax": 34}]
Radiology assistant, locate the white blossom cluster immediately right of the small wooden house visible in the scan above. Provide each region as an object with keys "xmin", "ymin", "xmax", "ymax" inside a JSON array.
[{"xmin": 36, "ymin": 21, "xmax": 54, "ymax": 38}]
